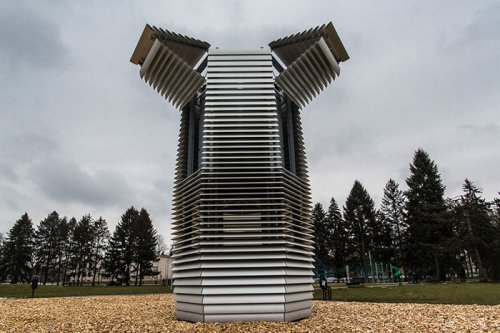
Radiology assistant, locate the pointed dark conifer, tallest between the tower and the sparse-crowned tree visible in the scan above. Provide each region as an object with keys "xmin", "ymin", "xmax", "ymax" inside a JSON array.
[{"xmin": 344, "ymin": 180, "xmax": 378, "ymax": 263}]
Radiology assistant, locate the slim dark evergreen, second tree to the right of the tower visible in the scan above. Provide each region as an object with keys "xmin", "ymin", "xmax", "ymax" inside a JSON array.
[{"xmin": 326, "ymin": 198, "xmax": 347, "ymax": 268}]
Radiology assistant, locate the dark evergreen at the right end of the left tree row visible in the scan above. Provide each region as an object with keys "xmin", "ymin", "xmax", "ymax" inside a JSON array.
[{"xmin": 132, "ymin": 208, "xmax": 158, "ymax": 285}]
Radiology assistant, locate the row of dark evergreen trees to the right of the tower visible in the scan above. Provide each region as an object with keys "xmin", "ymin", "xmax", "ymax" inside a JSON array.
[{"xmin": 312, "ymin": 149, "xmax": 500, "ymax": 281}]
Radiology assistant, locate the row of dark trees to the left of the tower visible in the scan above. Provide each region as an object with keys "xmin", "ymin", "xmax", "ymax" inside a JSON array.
[{"xmin": 0, "ymin": 207, "xmax": 165, "ymax": 285}]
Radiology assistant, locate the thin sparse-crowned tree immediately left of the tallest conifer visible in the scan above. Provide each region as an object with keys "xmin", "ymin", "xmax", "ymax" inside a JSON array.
[{"xmin": 380, "ymin": 179, "xmax": 408, "ymax": 272}]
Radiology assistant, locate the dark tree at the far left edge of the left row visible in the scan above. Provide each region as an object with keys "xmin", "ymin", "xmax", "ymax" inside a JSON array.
[{"xmin": 0, "ymin": 213, "xmax": 34, "ymax": 283}]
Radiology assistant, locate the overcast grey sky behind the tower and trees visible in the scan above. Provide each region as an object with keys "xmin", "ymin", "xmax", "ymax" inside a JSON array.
[{"xmin": 0, "ymin": 0, "xmax": 500, "ymax": 244}]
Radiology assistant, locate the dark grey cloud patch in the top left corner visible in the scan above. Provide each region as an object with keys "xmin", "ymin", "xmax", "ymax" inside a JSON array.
[{"xmin": 0, "ymin": 2, "xmax": 67, "ymax": 70}]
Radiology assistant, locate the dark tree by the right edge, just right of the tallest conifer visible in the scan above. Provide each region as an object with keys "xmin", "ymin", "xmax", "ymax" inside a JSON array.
[{"xmin": 454, "ymin": 179, "xmax": 499, "ymax": 281}]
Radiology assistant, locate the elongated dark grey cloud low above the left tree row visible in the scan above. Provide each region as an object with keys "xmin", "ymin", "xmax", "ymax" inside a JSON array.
[{"xmin": 31, "ymin": 159, "xmax": 135, "ymax": 207}]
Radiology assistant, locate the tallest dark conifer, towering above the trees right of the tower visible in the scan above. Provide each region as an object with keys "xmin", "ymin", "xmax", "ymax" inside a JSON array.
[{"xmin": 405, "ymin": 149, "xmax": 455, "ymax": 281}]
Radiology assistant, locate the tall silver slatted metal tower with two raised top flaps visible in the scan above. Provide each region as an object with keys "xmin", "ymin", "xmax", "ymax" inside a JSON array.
[{"xmin": 133, "ymin": 21, "xmax": 345, "ymax": 322}]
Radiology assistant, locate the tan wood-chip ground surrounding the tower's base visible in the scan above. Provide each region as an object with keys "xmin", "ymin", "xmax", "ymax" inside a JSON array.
[{"xmin": 0, "ymin": 294, "xmax": 500, "ymax": 333}]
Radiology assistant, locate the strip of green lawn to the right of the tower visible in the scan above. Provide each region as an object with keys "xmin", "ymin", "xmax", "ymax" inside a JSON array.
[{"xmin": 314, "ymin": 283, "xmax": 500, "ymax": 305}]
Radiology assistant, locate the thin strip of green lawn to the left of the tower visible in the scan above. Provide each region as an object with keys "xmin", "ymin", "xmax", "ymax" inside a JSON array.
[{"xmin": 0, "ymin": 284, "xmax": 172, "ymax": 298}]
